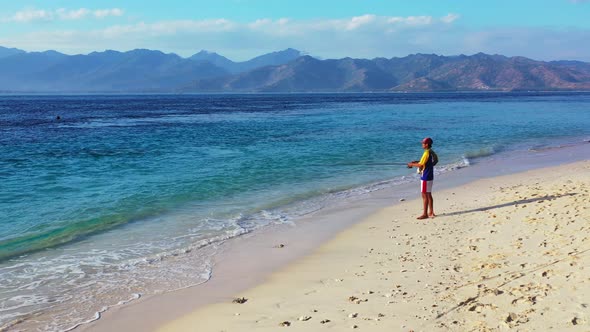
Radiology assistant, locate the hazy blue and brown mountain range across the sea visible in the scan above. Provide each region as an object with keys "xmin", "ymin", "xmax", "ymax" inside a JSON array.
[{"xmin": 0, "ymin": 47, "xmax": 590, "ymax": 93}]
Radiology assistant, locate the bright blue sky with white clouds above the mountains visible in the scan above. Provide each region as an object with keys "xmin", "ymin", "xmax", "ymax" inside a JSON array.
[{"xmin": 0, "ymin": 0, "xmax": 590, "ymax": 61}]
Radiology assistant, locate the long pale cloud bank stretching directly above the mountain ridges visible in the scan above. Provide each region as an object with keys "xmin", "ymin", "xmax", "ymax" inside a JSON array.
[{"xmin": 0, "ymin": 12, "xmax": 590, "ymax": 61}]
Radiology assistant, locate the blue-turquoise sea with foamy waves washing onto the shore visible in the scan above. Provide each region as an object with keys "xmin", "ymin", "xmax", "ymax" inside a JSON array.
[{"xmin": 0, "ymin": 92, "xmax": 590, "ymax": 331}]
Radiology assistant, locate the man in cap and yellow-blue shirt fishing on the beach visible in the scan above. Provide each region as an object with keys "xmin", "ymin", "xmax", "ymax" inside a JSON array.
[{"xmin": 408, "ymin": 137, "xmax": 438, "ymax": 219}]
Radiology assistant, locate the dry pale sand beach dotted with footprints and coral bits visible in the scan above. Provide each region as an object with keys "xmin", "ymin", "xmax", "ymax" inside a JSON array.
[{"xmin": 156, "ymin": 161, "xmax": 590, "ymax": 331}]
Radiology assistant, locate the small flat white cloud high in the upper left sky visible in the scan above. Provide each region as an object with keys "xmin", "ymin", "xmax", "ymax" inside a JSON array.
[{"xmin": 5, "ymin": 8, "xmax": 124, "ymax": 23}]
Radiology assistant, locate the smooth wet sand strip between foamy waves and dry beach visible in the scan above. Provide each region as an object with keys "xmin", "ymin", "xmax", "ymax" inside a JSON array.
[{"xmin": 83, "ymin": 144, "xmax": 588, "ymax": 331}]
